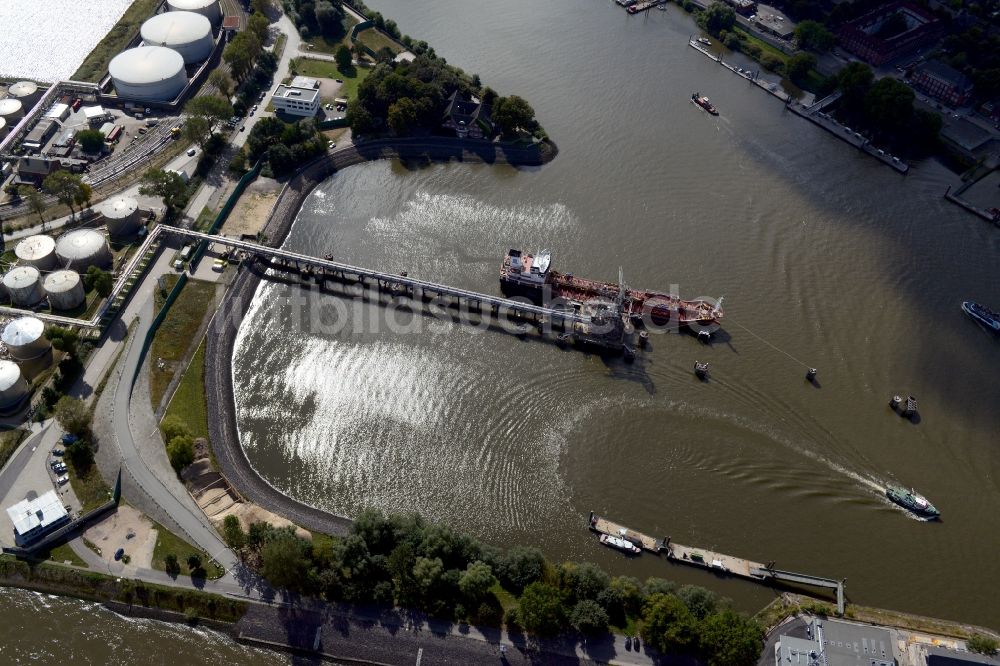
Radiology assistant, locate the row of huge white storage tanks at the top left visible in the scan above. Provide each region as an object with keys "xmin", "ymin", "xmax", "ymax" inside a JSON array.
[{"xmin": 108, "ymin": 0, "xmax": 222, "ymax": 102}]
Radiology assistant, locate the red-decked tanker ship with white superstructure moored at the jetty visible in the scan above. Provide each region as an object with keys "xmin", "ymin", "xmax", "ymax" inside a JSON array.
[{"xmin": 500, "ymin": 250, "xmax": 722, "ymax": 333}]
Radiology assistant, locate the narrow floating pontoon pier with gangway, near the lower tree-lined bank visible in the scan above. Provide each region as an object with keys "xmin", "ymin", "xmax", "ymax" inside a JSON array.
[{"xmin": 590, "ymin": 511, "xmax": 847, "ymax": 615}]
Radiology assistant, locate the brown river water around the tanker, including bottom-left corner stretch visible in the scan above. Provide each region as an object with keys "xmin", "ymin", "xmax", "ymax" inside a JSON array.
[{"xmin": 7, "ymin": 0, "xmax": 1000, "ymax": 652}]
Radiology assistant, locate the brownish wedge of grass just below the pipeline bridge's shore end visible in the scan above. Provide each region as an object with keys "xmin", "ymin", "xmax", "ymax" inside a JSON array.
[{"xmin": 149, "ymin": 275, "xmax": 215, "ymax": 409}]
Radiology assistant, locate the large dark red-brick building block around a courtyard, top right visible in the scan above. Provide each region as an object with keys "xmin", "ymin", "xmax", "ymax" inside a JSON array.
[{"xmin": 838, "ymin": 2, "xmax": 944, "ymax": 66}]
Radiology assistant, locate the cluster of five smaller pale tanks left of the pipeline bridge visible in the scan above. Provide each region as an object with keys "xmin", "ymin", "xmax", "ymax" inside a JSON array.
[{"xmin": 2, "ymin": 197, "xmax": 142, "ymax": 310}]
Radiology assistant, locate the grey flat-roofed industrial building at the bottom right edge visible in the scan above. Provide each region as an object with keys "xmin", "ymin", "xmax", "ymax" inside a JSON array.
[{"xmin": 774, "ymin": 618, "xmax": 896, "ymax": 666}]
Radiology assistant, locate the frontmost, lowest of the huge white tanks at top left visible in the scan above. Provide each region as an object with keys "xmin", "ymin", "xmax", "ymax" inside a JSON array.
[{"xmin": 108, "ymin": 46, "xmax": 187, "ymax": 102}]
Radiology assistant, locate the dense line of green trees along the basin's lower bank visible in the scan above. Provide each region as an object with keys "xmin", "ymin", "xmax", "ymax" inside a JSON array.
[{"xmin": 223, "ymin": 511, "xmax": 763, "ymax": 666}]
